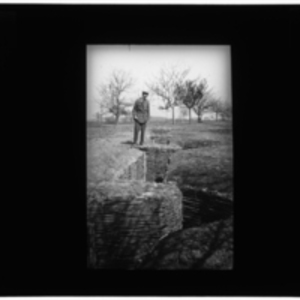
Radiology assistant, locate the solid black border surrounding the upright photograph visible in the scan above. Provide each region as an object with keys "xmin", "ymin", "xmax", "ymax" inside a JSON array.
[{"xmin": 0, "ymin": 5, "xmax": 299, "ymax": 296}]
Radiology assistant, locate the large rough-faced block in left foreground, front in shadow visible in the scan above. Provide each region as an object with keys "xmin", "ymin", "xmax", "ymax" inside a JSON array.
[{"xmin": 87, "ymin": 181, "xmax": 183, "ymax": 269}]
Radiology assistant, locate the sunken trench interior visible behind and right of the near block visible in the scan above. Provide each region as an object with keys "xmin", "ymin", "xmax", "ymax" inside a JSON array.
[{"xmin": 114, "ymin": 137, "xmax": 233, "ymax": 228}]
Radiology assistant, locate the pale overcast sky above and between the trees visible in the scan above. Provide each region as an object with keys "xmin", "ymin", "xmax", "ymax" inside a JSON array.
[{"xmin": 87, "ymin": 45, "xmax": 231, "ymax": 119}]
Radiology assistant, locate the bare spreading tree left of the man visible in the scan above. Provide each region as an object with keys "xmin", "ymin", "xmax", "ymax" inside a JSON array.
[{"xmin": 97, "ymin": 70, "xmax": 134, "ymax": 124}]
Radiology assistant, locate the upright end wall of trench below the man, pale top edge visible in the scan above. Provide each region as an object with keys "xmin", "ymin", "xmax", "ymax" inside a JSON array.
[{"xmin": 140, "ymin": 144, "xmax": 181, "ymax": 182}]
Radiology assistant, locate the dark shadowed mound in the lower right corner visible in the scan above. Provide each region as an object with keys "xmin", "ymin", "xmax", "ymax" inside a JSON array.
[{"xmin": 140, "ymin": 217, "xmax": 233, "ymax": 270}]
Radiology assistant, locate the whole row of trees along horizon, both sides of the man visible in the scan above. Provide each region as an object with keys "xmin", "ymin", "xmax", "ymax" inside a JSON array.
[{"xmin": 96, "ymin": 66, "xmax": 231, "ymax": 124}]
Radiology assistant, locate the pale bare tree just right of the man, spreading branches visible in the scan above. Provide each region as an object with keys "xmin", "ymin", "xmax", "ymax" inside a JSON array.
[{"xmin": 147, "ymin": 66, "xmax": 189, "ymax": 124}]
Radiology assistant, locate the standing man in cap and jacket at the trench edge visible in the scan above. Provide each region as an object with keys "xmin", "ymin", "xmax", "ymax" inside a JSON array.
[{"xmin": 132, "ymin": 92, "xmax": 150, "ymax": 145}]
